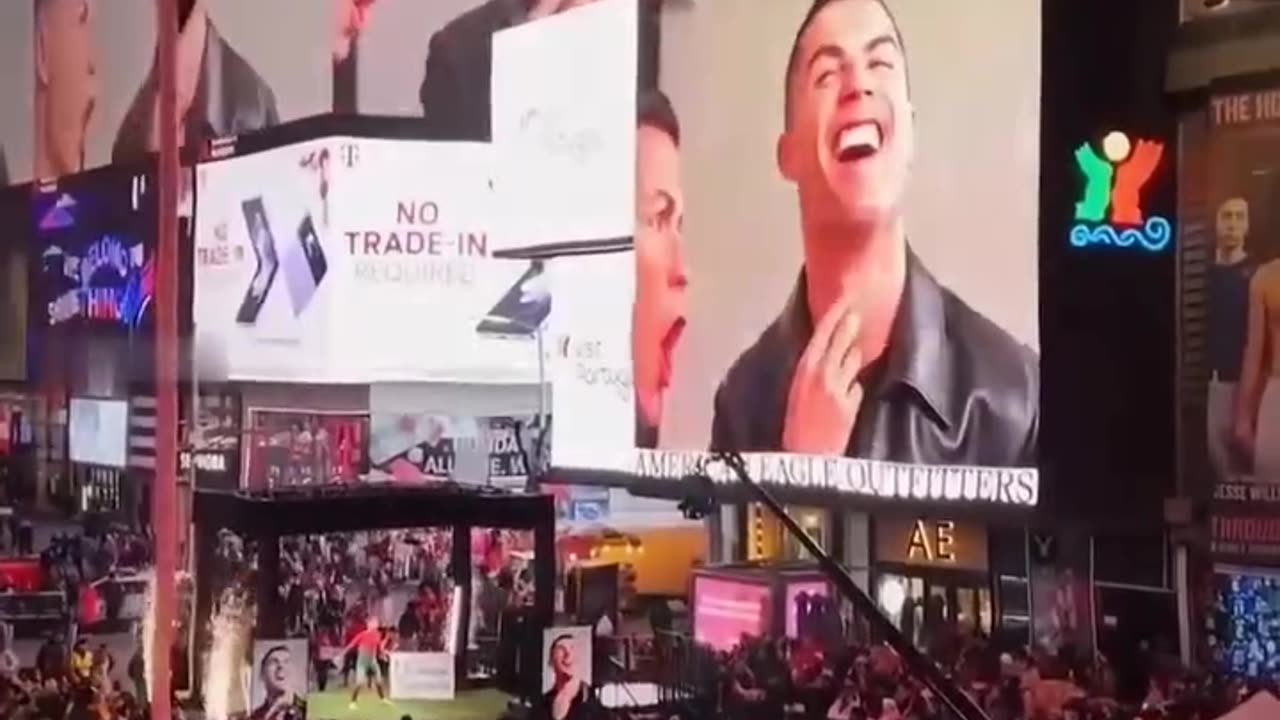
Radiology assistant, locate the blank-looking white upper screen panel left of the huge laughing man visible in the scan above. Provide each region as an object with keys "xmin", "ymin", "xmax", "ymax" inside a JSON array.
[{"xmin": 490, "ymin": 0, "xmax": 639, "ymax": 253}]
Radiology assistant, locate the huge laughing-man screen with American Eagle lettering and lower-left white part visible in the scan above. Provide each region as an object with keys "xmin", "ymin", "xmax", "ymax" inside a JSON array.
[{"xmin": 550, "ymin": 0, "xmax": 1041, "ymax": 506}]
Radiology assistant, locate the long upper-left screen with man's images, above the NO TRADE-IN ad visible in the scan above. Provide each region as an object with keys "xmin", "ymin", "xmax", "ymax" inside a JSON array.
[{"xmin": 15, "ymin": 0, "xmax": 658, "ymax": 178}]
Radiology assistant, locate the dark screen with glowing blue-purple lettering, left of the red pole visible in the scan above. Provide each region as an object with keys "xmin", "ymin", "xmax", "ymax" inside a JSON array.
[{"xmin": 31, "ymin": 169, "xmax": 155, "ymax": 331}]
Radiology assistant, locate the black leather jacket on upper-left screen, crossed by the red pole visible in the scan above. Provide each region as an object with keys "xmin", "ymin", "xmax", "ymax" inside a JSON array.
[{"xmin": 111, "ymin": 22, "xmax": 280, "ymax": 163}]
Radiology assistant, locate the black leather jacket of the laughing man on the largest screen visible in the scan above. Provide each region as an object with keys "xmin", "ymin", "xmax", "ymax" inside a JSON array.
[{"xmin": 712, "ymin": 250, "xmax": 1039, "ymax": 468}]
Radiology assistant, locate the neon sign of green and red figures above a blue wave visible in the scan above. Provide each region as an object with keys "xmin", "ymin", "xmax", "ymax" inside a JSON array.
[{"xmin": 1070, "ymin": 132, "xmax": 1174, "ymax": 252}]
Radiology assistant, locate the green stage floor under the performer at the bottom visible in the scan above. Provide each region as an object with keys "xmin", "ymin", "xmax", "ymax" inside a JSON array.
[{"xmin": 307, "ymin": 688, "xmax": 508, "ymax": 720}]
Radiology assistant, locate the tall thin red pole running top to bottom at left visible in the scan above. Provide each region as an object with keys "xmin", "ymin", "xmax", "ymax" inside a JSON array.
[{"xmin": 151, "ymin": 0, "xmax": 180, "ymax": 707}]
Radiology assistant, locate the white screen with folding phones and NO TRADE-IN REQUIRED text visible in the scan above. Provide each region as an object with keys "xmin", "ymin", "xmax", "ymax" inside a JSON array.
[{"xmin": 195, "ymin": 138, "xmax": 550, "ymax": 383}]
